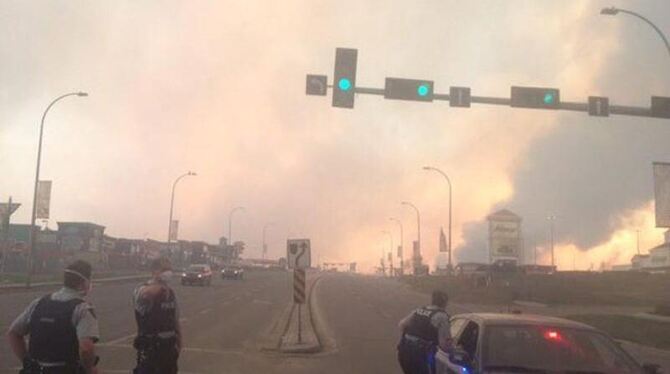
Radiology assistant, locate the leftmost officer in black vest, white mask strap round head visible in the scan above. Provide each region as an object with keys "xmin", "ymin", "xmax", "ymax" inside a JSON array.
[{"xmin": 7, "ymin": 261, "xmax": 100, "ymax": 374}]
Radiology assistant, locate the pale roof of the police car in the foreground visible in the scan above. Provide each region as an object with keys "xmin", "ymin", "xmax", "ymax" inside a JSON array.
[{"xmin": 454, "ymin": 313, "xmax": 596, "ymax": 331}]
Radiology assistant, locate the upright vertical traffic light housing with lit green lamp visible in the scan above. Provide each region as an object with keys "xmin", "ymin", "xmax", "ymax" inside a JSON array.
[{"xmin": 333, "ymin": 48, "xmax": 358, "ymax": 108}]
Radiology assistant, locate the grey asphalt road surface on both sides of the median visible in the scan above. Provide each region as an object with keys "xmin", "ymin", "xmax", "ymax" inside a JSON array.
[{"xmin": 0, "ymin": 272, "xmax": 668, "ymax": 374}]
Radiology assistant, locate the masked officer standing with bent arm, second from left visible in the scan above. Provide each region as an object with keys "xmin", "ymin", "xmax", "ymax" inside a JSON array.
[{"xmin": 133, "ymin": 258, "xmax": 181, "ymax": 374}]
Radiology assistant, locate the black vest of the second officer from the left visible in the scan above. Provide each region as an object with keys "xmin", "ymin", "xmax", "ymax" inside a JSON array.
[{"xmin": 135, "ymin": 286, "xmax": 177, "ymax": 338}]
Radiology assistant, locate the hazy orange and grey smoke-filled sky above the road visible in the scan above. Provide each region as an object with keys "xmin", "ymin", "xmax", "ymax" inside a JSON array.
[{"xmin": 0, "ymin": 0, "xmax": 670, "ymax": 268}]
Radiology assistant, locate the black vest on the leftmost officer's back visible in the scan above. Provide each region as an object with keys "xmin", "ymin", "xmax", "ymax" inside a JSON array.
[{"xmin": 28, "ymin": 295, "xmax": 84, "ymax": 365}]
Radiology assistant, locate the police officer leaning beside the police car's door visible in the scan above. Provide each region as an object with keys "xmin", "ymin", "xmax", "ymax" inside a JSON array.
[{"xmin": 398, "ymin": 290, "xmax": 451, "ymax": 374}]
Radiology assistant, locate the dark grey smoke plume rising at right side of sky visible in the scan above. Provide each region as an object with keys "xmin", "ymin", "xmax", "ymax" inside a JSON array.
[{"xmin": 459, "ymin": 2, "xmax": 670, "ymax": 261}]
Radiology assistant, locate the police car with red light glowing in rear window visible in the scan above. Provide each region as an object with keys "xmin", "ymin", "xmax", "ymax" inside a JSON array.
[{"xmin": 435, "ymin": 313, "xmax": 660, "ymax": 374}]
